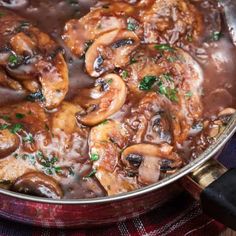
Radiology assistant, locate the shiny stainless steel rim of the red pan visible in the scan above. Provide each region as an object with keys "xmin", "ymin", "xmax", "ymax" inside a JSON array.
[{"xmin": 0, "ymin": 114, "xmax": 236, "ymax": 205}]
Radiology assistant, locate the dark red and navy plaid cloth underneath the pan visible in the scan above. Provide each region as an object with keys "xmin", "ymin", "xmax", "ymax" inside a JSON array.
[{"xmin": 0, "ymin": 135, "xmax": 236, "ymax": 236}]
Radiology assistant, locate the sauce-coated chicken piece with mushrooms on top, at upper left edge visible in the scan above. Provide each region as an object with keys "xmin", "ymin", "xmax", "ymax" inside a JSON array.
[{"xmin": 0, "ymin": 7, "xmax": 68, "ymax": 109}]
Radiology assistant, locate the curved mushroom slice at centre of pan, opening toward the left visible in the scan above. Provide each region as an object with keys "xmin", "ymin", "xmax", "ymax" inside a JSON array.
[{"xmin": 74, "ymin": 74, "xmax": 127, "ymax": 126}]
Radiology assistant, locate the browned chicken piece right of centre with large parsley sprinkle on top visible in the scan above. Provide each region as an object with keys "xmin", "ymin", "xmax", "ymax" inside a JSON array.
[{"xmin": 121, "ymin": 44, "xmax": 203, "ymax": 143}]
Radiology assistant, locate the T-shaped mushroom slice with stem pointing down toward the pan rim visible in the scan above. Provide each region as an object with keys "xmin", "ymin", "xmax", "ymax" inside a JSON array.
[{"xmin": 121, "ymin": 144, "xmax": 182, "ymax": 185}]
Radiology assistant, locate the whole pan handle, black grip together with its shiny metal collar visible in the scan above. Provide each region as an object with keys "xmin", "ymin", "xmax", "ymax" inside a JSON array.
[{"xmin": 181, "ymin": 159, "xmax": 236, "ymax": 230}]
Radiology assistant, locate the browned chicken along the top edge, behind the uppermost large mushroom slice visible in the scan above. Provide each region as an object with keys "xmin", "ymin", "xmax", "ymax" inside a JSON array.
[{"xmin": 63, "ymin": 0, "xmax": 216, "ymax": 56}]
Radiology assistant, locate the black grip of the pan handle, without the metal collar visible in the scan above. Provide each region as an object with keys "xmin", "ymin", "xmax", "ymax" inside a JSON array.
[{"xmin": 200, "ymin": 169, "xmax": 236, "ymax": 230}]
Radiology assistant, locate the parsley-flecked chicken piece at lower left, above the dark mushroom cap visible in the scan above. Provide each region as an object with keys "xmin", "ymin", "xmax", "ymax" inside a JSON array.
[{"xmin": 0, "ymin": 102, "xmax": 90, "ymax": 198}]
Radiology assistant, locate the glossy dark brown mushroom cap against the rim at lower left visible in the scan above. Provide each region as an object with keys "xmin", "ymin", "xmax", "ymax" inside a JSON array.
[{"xmin": 12, "ymin": 172, "xmax": 63, "ymax": 199}]
